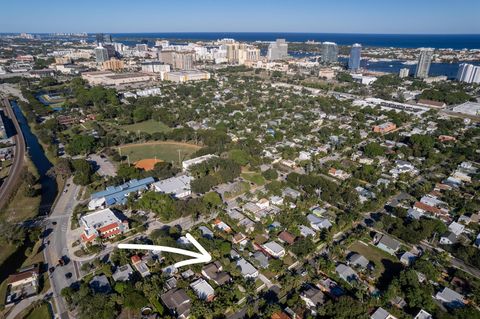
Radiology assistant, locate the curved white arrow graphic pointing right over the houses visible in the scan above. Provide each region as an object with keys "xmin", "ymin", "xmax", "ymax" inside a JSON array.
[{"xmin": 118, "ymin": 233, "xmax": 212, "ymax": 268}]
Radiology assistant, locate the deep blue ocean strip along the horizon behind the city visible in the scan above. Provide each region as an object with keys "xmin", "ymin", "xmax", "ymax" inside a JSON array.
[{"xmin": 108, "ymin": 32, "xmax": 480, "ymax": 50}]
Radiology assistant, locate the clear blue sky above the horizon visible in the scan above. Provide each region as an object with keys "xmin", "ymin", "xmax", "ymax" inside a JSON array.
[{"xmin": 0, "ymin": 0, "xmax": 480, "ymax": 34}]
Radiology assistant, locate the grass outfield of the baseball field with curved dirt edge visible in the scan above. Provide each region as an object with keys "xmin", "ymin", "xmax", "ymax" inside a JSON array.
[{"xmin": 119, "ymin": 142, "xmax": 201, "ymax": 165}]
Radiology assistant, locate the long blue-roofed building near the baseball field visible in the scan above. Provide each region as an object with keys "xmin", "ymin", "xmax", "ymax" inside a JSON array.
[{"xmin": 88, "ymin": 177, "xmax": 155, "ymax": 210}]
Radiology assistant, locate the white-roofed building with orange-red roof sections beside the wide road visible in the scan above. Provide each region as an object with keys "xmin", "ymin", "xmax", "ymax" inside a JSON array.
[{"xmin": 80, "ymin": 208, "xmax": 128, "ymax": 243}]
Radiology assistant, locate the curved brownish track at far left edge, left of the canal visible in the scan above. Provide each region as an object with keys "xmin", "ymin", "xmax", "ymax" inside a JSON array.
[{"xmin": 0, "ymin": 99, "xmax": 26, "ymax": 207}]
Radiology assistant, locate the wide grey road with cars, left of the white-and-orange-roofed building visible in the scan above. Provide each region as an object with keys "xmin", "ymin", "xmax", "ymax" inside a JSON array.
[{"xmin": 44, "ymin": 178, "xmax": 80, "ymax": 318}]
